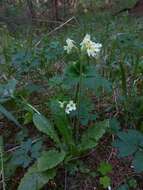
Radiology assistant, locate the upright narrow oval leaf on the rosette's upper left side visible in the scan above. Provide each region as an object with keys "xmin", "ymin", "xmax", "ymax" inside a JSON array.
[{"xmin": 33, "ymin": 113, "xmax": 60, "ymax": 144}]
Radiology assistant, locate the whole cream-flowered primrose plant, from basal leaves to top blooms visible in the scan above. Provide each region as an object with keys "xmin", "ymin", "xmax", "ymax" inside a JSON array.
[{"xmin": 18, "ymin": 34, "xmax": 111, "ymax": 190}]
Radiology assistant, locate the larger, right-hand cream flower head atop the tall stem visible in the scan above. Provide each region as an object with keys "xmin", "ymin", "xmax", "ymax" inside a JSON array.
[{"xmin": 80, "ymin": 34, "xmax": 102, "ymax": 57}]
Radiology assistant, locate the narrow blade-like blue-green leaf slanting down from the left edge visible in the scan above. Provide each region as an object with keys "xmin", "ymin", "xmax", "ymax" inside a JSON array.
[{"xmin": 0, "ymin": 104, "xmax": 21, "ymax": 127}]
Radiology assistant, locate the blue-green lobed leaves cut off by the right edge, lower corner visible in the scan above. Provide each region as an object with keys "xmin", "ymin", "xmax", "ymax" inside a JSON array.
[{"xmin": 113, "ymin": 129, "xmax": 143, "ymax": 172}]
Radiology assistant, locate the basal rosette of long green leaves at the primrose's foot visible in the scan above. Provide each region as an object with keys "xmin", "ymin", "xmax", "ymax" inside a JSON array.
[{"xmin": 19, "ymin": 109, "xmax": 108, "ymax": 190}]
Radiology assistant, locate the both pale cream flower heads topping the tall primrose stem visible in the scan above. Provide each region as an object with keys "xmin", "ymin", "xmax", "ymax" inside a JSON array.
[{"xmin": 64, "ymin": 34, "xmax": 102, "ymax": 58}]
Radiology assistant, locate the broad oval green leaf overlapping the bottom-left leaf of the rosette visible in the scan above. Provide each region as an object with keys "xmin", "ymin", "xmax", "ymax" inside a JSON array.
[{"xmin": 37, "ymin": 149, "xmax": 65, "ymax": 171}]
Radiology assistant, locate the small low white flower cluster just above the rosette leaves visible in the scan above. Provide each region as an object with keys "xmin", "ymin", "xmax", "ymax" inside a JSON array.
[{"xmin": 59, "ymin": 100, "xmax": 76, "ymax": 114}]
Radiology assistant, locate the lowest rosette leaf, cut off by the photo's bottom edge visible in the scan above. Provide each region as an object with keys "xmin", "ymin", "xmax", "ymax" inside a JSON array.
[{"xmin": 18, "ymin": 164, "xmax": 55, "ymax": 190}]
